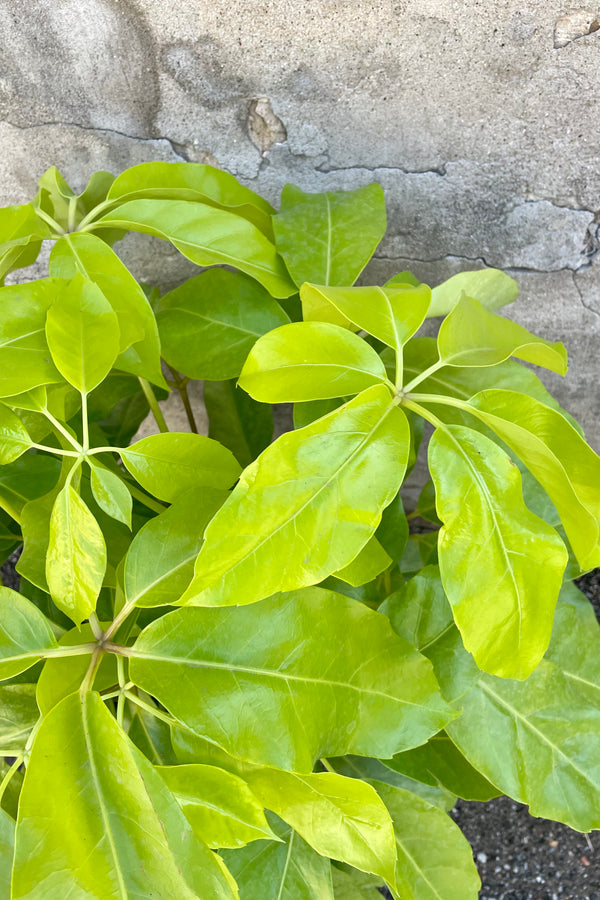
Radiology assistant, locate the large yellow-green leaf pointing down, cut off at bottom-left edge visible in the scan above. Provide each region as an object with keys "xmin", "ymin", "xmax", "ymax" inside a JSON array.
[{"xmin": 13, "ymin": 693, "xmax": 233, "ymax": 900}]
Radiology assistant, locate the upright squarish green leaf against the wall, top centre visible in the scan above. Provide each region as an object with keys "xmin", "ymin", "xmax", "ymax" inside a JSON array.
[{"xmin": 273, "ymin": 184, "xmax": 386, "ymax": 286}]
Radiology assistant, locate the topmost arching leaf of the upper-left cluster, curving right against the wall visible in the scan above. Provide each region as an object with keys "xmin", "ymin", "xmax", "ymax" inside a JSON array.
[{"xmin": 108, "ymin": 162, "xmax": 274, "ymax": 237}]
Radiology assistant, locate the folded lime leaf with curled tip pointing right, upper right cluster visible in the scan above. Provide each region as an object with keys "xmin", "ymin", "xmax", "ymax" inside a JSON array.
[{"xmin": 438, "ymin": 297, "xmax": 567, "ymax": 375}]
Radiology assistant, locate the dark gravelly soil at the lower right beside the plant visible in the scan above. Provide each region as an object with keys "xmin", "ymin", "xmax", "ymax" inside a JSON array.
[{"xmin": 452, "ymin": 569, "xmax": 600, "ymax": 900}]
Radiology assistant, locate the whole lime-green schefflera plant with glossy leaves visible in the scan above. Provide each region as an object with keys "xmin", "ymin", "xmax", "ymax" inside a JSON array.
[{"xmin": 0, "ymin": 163, "xmax": 600, "ymax": 900}]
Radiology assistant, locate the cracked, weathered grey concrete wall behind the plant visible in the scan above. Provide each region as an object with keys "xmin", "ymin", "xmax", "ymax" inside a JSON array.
[{"xmin": 0, "ymin": 0, "xmax": 600, "ymax": 449}]
